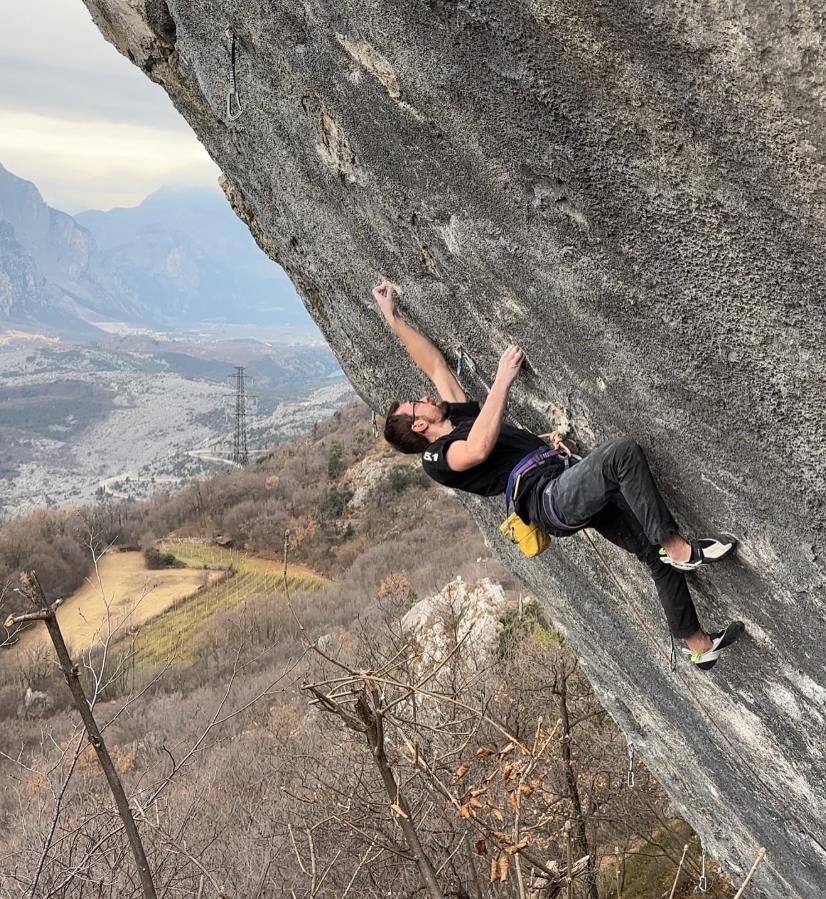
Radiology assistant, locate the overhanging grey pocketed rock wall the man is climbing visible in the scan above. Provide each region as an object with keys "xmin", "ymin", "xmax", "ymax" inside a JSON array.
[{"xmin": 80, "ymin": 0, "xmax": 826, "ymax": 899}]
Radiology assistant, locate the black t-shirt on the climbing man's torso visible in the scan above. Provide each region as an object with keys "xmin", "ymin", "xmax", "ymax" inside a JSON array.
[{"xmin": 422, "ymin": 403, "xmax": 547, "ymax": 496}]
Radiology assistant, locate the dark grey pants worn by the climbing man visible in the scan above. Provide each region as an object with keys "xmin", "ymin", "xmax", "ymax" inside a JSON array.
[{"xmin": 543, "ymin": 437, "xmax": 700, "ymax": 637}]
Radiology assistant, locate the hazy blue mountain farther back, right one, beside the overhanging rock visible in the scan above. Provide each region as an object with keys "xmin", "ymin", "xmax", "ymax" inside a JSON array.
[{"xmin": 75, "ymin": 188, "xmax": 309, "ymax": 324}]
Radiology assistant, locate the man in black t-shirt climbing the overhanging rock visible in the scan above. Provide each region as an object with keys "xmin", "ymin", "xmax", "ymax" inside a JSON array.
[{"xmin": 373, "ymin": 281, "xmax": 744, "ymax": 670}]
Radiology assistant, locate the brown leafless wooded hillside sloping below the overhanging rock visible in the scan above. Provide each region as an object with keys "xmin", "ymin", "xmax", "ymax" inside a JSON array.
[{"xmin": 0, "ymin": 405, "xmax": 728, "ymax": 899}]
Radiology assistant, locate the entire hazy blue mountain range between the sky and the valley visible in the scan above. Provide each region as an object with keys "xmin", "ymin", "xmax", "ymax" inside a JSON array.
[{"xmin": 0, "ymin": 165, "xmax": 310, "ymax": 334}]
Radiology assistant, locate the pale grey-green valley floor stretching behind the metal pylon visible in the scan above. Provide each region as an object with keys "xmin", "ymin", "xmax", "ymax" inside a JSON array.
[{"xmin": 0, "ymin": 341, "xmax": 352, "ymax": 517}]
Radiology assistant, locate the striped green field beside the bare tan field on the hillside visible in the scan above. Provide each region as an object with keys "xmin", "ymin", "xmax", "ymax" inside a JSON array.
[{"xmin": 135, "ymin": 543, "xmax": 330, "ymax": 666}]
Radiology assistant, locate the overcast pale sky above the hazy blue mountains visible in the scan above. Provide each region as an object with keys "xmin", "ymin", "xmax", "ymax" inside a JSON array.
[{"xmin": 0, "ymin": 0, "xmax": 220, "ymax": 213}]
